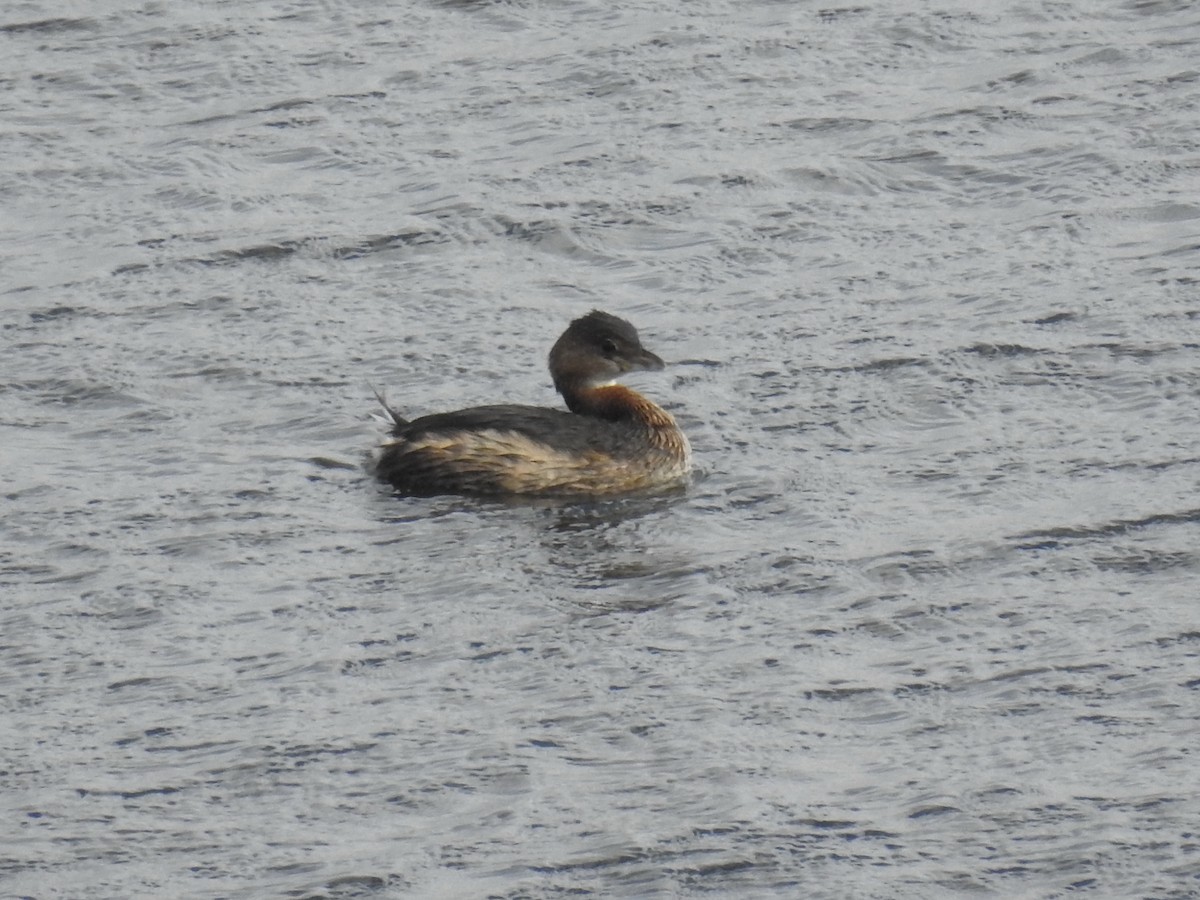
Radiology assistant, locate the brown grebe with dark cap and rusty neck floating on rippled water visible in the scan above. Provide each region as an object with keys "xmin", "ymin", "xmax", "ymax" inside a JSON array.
[{"xmin": 373, "ymin": 310, "xmax": 691, "ymax": 496}]
